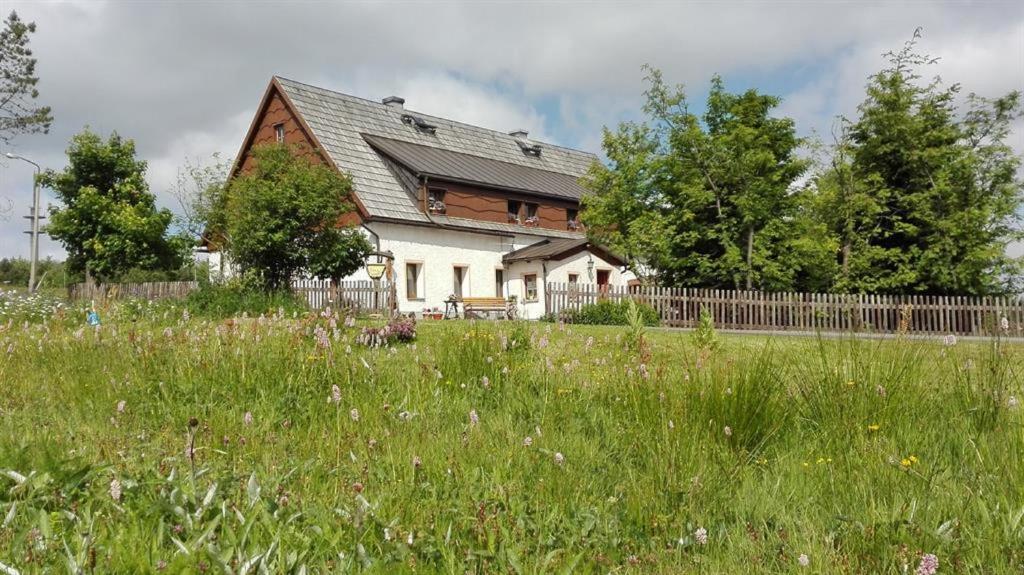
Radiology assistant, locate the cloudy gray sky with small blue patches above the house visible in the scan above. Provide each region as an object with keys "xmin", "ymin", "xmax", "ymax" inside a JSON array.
[{"xmin": 0, "ymin": 0, "xmax": 1024, "ymax": 257}]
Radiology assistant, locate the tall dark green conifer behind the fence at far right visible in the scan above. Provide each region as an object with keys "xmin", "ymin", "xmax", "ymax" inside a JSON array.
[{"xmin": 837, "ymin": 31, "xmax": 1024, "ymax": 295}]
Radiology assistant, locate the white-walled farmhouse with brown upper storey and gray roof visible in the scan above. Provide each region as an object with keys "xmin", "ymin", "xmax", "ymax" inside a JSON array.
[{"xmin": 211, "ymin": 77, "xmax": 632, "ymax": 318}]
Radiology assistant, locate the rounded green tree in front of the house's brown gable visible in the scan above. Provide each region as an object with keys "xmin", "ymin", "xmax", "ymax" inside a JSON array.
[{"xmin": 219, "ymin": 144, "xmax": 370, "ymax": 290}]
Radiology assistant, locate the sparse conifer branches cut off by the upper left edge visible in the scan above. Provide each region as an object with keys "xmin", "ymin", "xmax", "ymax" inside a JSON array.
[{"xmin": 0, "ymin": 11, "xmax": 53, "ymax": 143}]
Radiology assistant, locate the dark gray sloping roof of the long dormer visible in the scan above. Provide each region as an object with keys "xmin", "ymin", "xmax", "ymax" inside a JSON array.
[{"xmin": 364, "ymin": 134, "xmax": 584, "ymax": 201}]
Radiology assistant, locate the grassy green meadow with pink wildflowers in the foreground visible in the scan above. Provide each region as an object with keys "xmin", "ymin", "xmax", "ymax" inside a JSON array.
[{"xmin": 0, "ymin": 292, "xmax": 1024, "ymax": 574}]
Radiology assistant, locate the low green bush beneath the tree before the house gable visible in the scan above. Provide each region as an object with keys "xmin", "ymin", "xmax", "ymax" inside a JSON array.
[{"xmin": 185, "ymin": 279, "xmax": 306, "ymax": 317}]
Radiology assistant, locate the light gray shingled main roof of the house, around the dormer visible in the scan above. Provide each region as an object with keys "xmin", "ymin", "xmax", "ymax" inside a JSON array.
[{"xmin": 276, "ymin": 77, "xmax": 597, "ymax": 228}]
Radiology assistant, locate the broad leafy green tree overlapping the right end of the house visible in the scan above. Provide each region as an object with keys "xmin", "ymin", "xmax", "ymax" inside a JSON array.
[{"xmin": 583, "ymin": 68, "xmax": 820, "ymax": 290}]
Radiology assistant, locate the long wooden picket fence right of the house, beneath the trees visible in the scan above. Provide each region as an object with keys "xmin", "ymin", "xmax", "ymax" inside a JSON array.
[{"xmin": 545, "ymin": 283, "xmax": 1024, "ymax": 336}]
